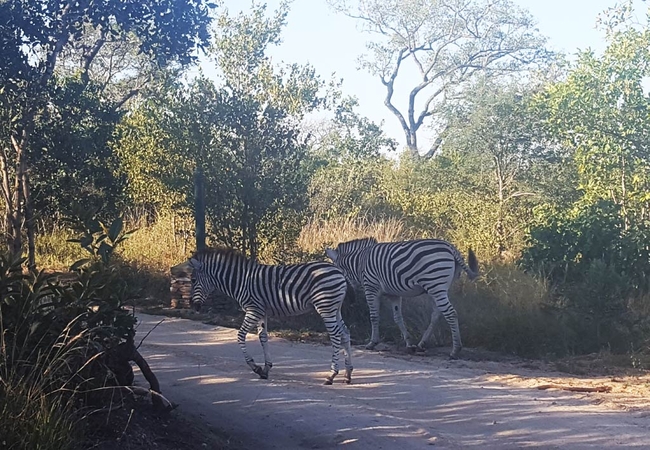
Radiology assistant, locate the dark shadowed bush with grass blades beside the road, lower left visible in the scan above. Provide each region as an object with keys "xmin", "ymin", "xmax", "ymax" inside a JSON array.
[{"xmin": 0, "ymin": 216, "xmax": 140, "ymax": 449}]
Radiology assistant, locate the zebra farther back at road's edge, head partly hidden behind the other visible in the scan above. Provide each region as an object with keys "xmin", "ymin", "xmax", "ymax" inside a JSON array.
[{"xmin": 325, "ymin": 238, "xmax": 478, "ymax": 359}]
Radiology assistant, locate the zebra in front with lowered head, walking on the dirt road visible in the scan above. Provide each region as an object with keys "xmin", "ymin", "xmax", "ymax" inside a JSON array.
[{"xmin": 190, "ymin": 249, "xmax": 352, "ymax": 384}]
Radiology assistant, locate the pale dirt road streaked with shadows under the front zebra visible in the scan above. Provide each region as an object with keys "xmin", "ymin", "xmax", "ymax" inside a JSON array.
[{"xmin": 138, "ymin": 314, "xmax": 650, "ymax": 450}]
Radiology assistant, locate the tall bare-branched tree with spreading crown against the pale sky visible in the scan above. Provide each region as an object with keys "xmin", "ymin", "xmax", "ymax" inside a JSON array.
[{"xmin": 328, "ymin": 0, "xmax": 546, "ymax": 158}]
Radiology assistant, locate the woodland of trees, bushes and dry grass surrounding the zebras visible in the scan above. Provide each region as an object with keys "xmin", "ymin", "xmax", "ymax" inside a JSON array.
[{"xmin": 0, "ymin": 0, "xmax": 650, "ymax": 448}]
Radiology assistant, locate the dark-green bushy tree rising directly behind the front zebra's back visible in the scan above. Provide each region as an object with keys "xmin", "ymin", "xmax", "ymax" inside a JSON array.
[{"xmin": 204, "ymin": 92, "xmax": 309, "ymax": 258}]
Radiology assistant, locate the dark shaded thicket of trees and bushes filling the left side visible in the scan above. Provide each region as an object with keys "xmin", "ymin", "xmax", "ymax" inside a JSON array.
[{"xmin": 0, "ymin": 0, "xmax": 214, "ymax": 449}]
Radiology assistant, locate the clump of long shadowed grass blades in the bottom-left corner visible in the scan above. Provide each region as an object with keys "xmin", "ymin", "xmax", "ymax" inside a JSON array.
[{"xmin": 0, "ymin": 310, "xmax": 96, "ymax": 450}]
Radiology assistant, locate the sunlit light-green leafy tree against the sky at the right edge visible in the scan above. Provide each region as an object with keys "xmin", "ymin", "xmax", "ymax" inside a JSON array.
[{"xmin": 538, "ymin": 2, "xmax": 650, "ymax": 229}]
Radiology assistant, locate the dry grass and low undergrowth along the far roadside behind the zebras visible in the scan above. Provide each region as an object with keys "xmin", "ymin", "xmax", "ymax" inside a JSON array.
[{"xmin": 31, "ymin": 215, "xmax": 650, "ymax": 361}]
